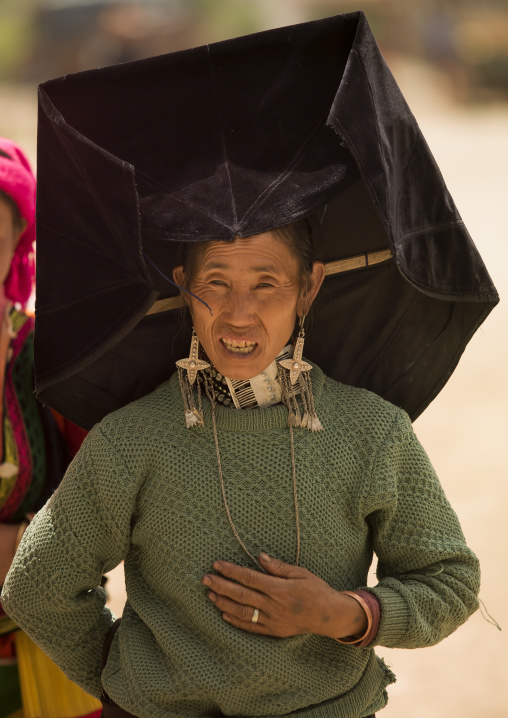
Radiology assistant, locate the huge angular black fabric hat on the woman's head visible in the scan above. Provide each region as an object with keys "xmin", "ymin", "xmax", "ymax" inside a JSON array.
[{"xmin": 35, "ymin": 12, "xmax": 498, "ymax": 428}]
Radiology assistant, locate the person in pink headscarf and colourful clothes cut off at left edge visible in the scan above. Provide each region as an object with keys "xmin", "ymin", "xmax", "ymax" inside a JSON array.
[{"xmin": 0, "ymin": 138, "xmax": 100, "ymax": 718}]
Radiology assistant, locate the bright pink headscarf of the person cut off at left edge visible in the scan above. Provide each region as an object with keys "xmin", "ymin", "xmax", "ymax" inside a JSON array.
[{"xmin": 0, "ymin": 137, "xmax": 36, "ymax": 307}]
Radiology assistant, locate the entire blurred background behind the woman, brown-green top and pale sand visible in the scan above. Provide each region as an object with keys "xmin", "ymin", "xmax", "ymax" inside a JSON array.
[{"xmin": 0, "ymin": 0, "xmax": 508, "ymax": 718}]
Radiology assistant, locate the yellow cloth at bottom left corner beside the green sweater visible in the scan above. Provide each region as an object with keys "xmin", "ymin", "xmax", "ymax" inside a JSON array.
[{"xmin": 16, "ymin": 631, "xmax": 102, "ymax": 718}]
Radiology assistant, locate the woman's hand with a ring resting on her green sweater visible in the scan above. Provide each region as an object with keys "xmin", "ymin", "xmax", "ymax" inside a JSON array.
[{"xmin": 203, "ymin": 553, "xmax": 367, "ymax": 638}]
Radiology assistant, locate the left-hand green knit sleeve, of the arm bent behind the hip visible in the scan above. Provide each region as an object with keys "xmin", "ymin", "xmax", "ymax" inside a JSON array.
[{"xmin": 2, "ymin": 427, "xmax": 141, "ymax": 697}]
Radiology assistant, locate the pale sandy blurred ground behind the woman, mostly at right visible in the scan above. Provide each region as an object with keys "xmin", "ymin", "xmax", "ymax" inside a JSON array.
[{"xmin": 0, "ymin": 57, "xmax": 508, "ymax": 718}]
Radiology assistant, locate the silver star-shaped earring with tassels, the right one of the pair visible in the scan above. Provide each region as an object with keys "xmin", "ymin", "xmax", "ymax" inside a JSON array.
[{"xmin": 279, "ymin": 315, "xmax": 323, "ymax": 431}]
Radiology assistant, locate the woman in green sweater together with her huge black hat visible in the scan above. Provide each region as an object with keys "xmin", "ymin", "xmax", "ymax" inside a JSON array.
[{"xmin": 2, "ymin": 13, "xmax": 497, "ymax": 718}]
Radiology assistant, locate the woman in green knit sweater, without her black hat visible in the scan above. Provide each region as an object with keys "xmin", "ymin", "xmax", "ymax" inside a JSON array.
[{"xmin": 3, "ymin": 220, "xmax": 478, "ymax": 717}]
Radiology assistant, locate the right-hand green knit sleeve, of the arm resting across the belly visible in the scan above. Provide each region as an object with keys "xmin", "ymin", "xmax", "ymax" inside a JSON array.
[{"xmin": 366, "ymin": 412, "xmax": 480, "ymax": 648}]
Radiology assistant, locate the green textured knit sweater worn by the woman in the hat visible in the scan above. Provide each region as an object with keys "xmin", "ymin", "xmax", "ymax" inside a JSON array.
[{"xmin": 2, "ymin": 368, "xmax": 479, "ymax": 718}]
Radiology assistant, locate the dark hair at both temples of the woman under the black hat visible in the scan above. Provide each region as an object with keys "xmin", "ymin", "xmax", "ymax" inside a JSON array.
[{"xmin": 183, "ymin": 217, "xmax": 316, "ymax": 288}]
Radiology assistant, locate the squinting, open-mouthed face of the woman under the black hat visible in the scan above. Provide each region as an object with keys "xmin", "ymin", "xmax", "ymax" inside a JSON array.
[{"xmin": 173, "ymin": 232, "xmax": 324, "ymax": 379}]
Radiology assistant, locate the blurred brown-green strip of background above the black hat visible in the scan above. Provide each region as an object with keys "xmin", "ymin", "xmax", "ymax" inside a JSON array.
[{"xmin": 0, "ymin": 0, "xmax": 508, "ymax": 101}]
